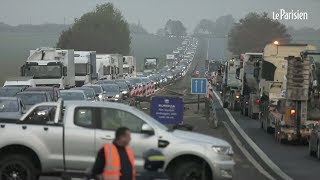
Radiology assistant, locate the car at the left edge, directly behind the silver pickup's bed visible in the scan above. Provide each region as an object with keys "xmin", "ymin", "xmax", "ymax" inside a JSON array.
[{"xmin": 0, "ymin": 97, "xmax": 25, "ymax": 119}]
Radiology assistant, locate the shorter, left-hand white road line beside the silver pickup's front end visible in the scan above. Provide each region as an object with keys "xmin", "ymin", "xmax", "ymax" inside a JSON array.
[{"xmin": 223, "ymin": 122, "xmax": 276, "ymax": 180}]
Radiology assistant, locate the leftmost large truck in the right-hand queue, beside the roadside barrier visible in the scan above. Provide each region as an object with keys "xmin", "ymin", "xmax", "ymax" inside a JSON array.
[{"xmin": 222, "ymin": 56, "xmax": 242, "ymax": 110}]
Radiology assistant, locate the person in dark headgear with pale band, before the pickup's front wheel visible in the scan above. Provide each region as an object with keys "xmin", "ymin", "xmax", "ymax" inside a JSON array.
[{"xmin": 137, "ymin": 149, "xmax": 169, "ymax": 180}]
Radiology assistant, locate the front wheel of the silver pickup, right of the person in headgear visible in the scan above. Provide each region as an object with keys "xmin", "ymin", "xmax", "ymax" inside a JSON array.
[{"xmin": 170, "ymin": 162, "xmax": 209, "ymax": 180}]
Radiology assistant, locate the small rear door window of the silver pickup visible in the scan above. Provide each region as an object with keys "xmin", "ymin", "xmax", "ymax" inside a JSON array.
[{"xmin": 74, "ymin": 107, "xmax": 95, "ymax": 128}]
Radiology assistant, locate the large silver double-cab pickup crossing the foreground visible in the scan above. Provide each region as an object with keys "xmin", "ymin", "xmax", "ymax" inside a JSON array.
[{"xmin": 0, "ymin": 100, "xmax": 235, "ymax": 180}]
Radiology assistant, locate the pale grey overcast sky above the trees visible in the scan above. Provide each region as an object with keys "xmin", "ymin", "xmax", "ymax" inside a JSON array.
[{"xmin": 0, "ymin": 0, "xmax": 320, "ymax": 32}]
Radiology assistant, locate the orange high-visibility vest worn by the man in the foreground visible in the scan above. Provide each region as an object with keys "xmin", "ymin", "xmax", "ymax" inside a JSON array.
[{"xmin": 103, "ymin": 143, "xmax": 136, "ymax": 180}]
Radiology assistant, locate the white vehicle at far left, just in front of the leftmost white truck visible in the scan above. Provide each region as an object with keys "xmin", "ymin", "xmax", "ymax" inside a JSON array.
[{"xmin": 3, "ymin": 77, "xmax": 36, "ymax": 88}]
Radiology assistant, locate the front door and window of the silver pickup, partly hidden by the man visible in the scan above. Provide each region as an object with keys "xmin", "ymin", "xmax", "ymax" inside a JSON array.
[{"xmin": 96, "ymin": 108, "xmax": 158, "ymax": 171}]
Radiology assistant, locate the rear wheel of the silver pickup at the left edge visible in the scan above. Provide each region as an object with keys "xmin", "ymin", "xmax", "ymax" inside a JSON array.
[{"xmin": 0, "ymin": 154, "xmax": 39, "ymax": 180}]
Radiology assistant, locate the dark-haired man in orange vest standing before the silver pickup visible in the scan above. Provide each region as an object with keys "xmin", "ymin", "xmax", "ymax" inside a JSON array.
[{"xmin": 91, "ymin": 127, "xmax": 136, "ymax": 180}]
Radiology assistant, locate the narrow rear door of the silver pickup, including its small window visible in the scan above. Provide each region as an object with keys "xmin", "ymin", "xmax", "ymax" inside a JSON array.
[{"xmin": 65, "ymin": 107, "xmax": 96, "ymax": 171}]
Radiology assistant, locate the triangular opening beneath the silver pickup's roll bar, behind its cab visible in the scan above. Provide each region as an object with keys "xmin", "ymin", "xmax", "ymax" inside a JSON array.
[{"xmin": 24, "ymin": 106, "xmax": 57, "ymax": 125}]
